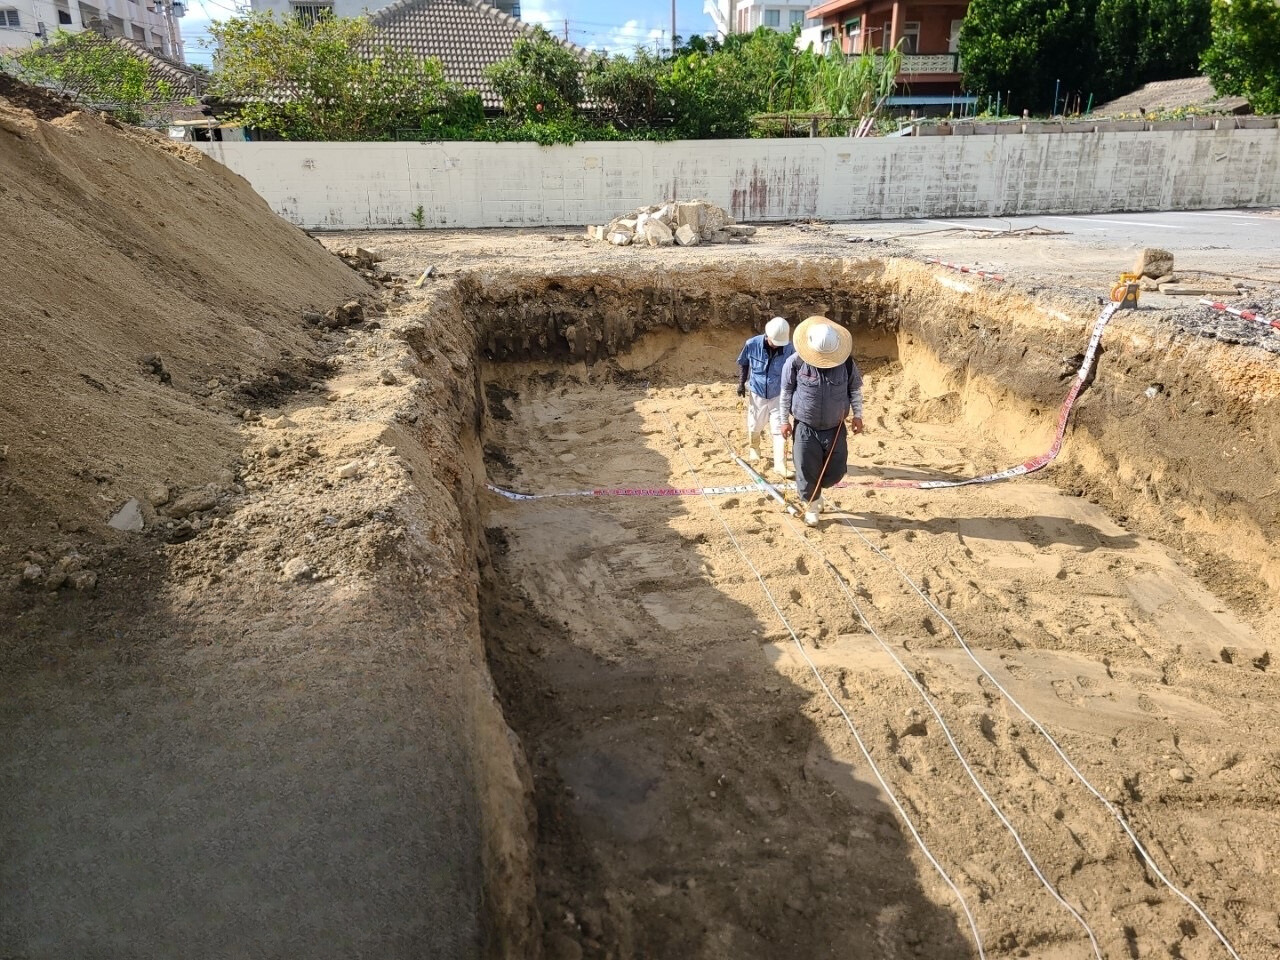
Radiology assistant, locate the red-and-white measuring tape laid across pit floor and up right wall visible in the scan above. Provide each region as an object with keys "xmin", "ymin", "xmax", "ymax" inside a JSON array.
[{"xmin": 485, "ymin": 302, "xmax": 1121, "ymax": 500}]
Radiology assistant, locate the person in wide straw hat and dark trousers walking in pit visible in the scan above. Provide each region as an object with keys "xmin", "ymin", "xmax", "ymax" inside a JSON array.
[{"xmin": 780, "ymin": 316, "xmax": 863, "ymax": 526}]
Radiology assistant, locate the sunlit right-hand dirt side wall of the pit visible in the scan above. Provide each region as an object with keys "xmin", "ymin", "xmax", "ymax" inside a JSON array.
[{"xmin": 881, "ymin": 260, "xmax": 1280, "ymax": 612}]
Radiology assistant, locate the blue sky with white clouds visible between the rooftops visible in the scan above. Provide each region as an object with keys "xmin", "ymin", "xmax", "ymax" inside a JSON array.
[{"xmin": 182, "ymin": 0, "xmax": 712, "ymax": 64}]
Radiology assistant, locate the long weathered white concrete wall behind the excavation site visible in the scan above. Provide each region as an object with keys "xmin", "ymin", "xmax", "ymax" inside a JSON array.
[{"xmin": 200, "ymin": 120, "xmax": 1280, "ymax": 229}]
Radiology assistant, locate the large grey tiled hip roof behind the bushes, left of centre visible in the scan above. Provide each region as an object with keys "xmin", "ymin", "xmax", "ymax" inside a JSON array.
[{"xmin": 370, "ymin": 0, "xmax": 588, "ymax": 110}]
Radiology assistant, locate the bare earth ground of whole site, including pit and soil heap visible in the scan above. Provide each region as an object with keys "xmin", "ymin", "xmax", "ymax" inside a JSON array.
[{"xmin": 0, "ymin": 95, "xmax": 1280, "ymax": 960}]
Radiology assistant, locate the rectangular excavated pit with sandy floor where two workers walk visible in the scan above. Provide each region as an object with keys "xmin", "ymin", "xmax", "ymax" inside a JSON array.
[{"xmin": 458, "ymin": 261, "xmax": 1280, "ymax": 957}]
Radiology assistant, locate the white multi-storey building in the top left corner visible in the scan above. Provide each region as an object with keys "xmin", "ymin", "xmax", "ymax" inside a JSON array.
[{"xmin": 0, "ymin": 0, "xmax": 186, "ymax": 61}]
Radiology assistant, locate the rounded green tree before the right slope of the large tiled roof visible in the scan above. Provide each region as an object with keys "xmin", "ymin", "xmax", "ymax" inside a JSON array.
[{"xmin": 485, "ymin": 27, "xmax": 586, "ymax": 123}]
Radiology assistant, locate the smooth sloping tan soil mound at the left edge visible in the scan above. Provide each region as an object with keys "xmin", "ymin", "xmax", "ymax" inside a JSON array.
[{"xmin": 0, "ymin": 78, "xmax": 370, "ymax": 576}]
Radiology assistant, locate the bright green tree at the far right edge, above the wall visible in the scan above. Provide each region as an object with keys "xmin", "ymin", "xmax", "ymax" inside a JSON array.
[{"xmin": 1203, "ymin": 0, "xmax": 1280, "ymax": 114}]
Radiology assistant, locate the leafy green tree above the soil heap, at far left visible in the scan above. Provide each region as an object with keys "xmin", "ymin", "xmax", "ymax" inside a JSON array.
[{"xmin": 13, "ymin": 31, "xmax": 174, "ymax": 123}]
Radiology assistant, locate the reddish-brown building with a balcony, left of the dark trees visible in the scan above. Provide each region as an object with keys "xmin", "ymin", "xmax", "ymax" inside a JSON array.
[{"xmin": 806, "ymin": 0, "xmax": 969, "ymax": 106}]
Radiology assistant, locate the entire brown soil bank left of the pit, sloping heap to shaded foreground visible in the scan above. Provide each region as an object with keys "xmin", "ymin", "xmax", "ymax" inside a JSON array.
[{"xmin": 0, "ymin": 86, "xmax": 531, "ymax": 960}]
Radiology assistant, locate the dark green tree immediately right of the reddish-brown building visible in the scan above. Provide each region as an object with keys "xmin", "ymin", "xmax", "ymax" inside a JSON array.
[{"xmin": 960, "ymin": 0, "xmax": 1097, "ymax": 110}]
